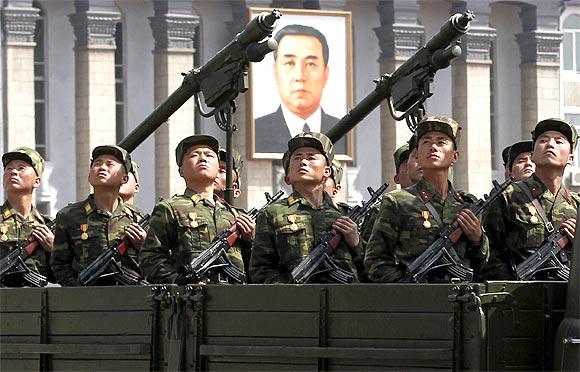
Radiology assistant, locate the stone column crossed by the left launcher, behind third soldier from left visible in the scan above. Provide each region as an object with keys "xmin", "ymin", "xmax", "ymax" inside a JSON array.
[{"xmin": 149, "ymin": 0, "xmax": 199, "ymax": 198}]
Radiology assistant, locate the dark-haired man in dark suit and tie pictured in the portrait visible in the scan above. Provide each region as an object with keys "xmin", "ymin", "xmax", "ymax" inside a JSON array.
[{"xmin": 248, "ymin": 8, "xmax": 347, "ymax": 158}]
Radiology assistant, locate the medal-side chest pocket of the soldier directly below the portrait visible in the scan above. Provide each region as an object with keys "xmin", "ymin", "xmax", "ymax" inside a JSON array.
[{"xmin": 276, "ymin": 221, "xmax": 311, "ymax": 267}]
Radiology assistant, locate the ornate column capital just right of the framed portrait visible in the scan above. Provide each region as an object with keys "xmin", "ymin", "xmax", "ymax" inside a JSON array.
[{"xmin": 374, "ymin": 0, "xmax": 425, "ymax": 59}]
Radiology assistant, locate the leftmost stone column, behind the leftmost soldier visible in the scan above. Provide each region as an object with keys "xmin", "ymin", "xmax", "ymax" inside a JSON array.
[{"xmin": 2, "ymin": 0, "xmax": 39, "ymax": 151}]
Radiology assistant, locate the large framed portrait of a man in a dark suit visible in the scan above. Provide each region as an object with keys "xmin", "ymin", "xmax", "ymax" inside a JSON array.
[{"xmin": 246, "ymin": 8, "xmax": 354, "ymax": 160}]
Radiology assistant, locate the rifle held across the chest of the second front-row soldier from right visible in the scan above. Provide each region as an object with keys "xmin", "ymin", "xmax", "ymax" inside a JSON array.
[{"xmin": 407, "ymin": 177, "xmax": 514, "ymax": 283}]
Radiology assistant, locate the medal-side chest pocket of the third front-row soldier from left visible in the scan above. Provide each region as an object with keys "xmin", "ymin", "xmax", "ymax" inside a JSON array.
[{"xmin": 173, "ymin": 212, "xmax": 210, "ymax": 264}]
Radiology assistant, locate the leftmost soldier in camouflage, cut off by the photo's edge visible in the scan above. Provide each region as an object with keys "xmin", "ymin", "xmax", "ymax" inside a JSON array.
[{"xmin": 0, "ymin": 147, "xmax": 54, "ymax": 287}]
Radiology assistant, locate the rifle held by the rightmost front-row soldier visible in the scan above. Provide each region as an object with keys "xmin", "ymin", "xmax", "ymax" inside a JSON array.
[{"xmin": 516, "ymin": 228, "xmax": 570, "ymax": 281}]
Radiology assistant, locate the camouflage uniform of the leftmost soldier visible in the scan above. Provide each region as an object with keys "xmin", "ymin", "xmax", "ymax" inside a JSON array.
[{"xmin": 0, "ymin": 201, "xmax": 54, "ymax": 287}]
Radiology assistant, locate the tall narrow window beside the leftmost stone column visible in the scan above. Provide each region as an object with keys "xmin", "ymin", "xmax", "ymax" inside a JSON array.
[{"xmin": 34, "ymin": 2, "xmax": 48, "ymax": 160}]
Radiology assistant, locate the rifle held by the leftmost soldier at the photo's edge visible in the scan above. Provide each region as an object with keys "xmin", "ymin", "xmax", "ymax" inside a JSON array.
[{"xmin": 0, "ymin": 221, "xmax": 55, "ymax": 287}]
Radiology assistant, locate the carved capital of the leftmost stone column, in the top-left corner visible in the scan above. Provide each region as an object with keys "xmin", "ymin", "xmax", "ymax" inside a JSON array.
[{"xmin": 2, "ymin": 1, "xmax": 40, "ymax": 44}]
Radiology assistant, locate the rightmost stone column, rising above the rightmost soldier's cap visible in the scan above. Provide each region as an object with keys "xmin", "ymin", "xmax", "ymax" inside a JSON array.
[{"xmin": 516, "ymin": 1, "xmax": 562, "ymax": 138}]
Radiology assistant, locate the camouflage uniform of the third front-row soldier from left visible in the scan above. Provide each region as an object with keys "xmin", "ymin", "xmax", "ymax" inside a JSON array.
[{"xmin": 139, "ymin": 189, "xmax": 251, "ymax": 283}]
